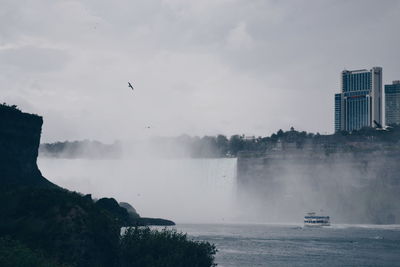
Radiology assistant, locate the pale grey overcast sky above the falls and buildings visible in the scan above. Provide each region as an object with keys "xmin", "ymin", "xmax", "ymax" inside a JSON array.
[{"xmin": 0, "ymin": 0, "xmax": 400, "ymax": 142}]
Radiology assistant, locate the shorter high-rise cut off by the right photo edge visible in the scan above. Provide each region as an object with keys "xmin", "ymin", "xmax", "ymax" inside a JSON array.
[{"xmin": 385, "ymin": 81, "xmax": 400, "ymax": 125}]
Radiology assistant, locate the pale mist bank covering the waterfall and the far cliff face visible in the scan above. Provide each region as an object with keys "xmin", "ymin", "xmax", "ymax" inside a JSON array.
[{"xmin": 39, "ymin": 136, "xmax": 400, "ymax": 224}]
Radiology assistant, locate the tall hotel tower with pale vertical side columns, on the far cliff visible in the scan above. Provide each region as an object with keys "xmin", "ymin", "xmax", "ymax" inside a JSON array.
[{"xmin": 335, "ymin": 67, "xmax": 382, "ymax": 132}]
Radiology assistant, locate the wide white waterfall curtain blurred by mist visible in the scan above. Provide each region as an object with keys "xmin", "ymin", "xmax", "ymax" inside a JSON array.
[{"xmin": 38, "ymin": 157, "xmax": 236, "ymax": 222}]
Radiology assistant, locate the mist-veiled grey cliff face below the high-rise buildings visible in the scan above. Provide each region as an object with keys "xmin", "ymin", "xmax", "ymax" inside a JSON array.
[{"xmin": 238, "ymin": 153, "xmax": 400, "ymax": 224}]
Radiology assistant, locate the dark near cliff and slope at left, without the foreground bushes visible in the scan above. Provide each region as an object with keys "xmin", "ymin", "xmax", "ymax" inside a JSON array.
[{"xmin": 0, "ymin": 105, "xmax": 121, "ymax": 267}]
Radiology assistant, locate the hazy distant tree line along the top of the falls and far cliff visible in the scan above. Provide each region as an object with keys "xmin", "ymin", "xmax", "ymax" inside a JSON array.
[{"xmin": 40, "ymin": 125, "xmax": 400, "ymax": 158}]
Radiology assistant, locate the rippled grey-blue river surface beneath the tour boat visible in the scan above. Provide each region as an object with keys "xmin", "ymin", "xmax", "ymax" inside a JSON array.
[{"xmin": 176, "ymin": 224, "xmax": 400, "ymax": 267}]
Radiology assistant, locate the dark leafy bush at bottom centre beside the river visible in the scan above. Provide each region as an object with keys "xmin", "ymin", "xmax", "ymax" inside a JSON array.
[{"xmin": 120, "ymin": 227, "xmax": 217, "ymax": 267}]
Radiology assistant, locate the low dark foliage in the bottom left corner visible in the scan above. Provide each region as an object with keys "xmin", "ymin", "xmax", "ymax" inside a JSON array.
[{"xmin": 0, "ymin": 237, "xmax": 66, "ymax": 267}]
